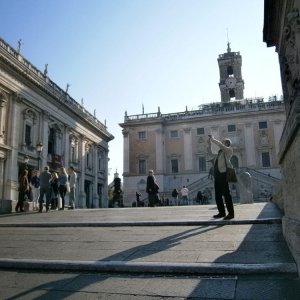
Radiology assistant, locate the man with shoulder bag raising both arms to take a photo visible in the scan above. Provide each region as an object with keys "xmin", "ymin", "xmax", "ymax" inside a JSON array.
[{"xmin": 207, "ymin": 135, "xmax": 234, "ymax": 220}]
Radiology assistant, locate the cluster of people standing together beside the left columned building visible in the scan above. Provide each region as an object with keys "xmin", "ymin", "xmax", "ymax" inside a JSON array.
[{"xmin": 15, "ymin": 166, "xmax": 77, "ymax": 213}]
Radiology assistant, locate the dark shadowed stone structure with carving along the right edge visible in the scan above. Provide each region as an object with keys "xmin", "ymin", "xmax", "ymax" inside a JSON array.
[{"xmin": 263, "ymin": 0, "xmax": 300, "ymax": 273}]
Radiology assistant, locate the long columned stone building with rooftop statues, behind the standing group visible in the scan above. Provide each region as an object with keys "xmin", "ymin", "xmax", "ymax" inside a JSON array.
[{"xmin": 0, "ymin": 39, "xmax": 113, "ymax": 212}]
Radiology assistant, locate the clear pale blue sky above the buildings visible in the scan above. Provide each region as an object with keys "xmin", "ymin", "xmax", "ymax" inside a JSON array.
[{"xmin": 0, "ymin": 0, "xmax": 282, "ymax": 182}]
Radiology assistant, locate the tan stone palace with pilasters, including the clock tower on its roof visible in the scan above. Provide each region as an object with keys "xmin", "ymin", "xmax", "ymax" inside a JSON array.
[{"xmin": 120, "ymin": 44, "xmax": 285, "ymax": 206}]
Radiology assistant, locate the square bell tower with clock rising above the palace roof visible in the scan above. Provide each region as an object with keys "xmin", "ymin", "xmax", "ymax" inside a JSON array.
[{"xmin": 218, "ymin": 42, "xmax": 244, "ymax": 102}]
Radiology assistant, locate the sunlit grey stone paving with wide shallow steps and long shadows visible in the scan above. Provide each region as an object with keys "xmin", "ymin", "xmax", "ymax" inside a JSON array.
[{"xmin": 0, "ymin": 203, "xmax": 300, "ymax": 299}]
